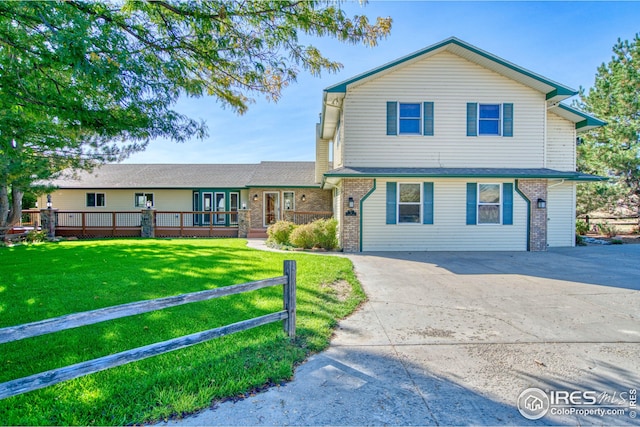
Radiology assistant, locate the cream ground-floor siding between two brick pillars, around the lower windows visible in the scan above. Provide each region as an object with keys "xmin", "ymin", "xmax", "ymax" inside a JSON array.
[{"xmin": 362, "ymin": 178, "xmax": 527, "ymax": 251}]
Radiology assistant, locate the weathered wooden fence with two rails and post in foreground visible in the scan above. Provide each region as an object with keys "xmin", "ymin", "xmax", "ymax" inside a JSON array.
[{"xmin": 0, "ymin": 260, "xmax": 296, "ymax": 399}]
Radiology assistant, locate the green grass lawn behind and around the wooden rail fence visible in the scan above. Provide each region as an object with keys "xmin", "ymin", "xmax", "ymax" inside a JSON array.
[{"xmin": 0, "ymin": 239, "xmax": 364, "ymax": 425}]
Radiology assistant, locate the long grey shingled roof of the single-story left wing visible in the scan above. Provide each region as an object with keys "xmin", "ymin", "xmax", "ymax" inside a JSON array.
[{"xmin": 47, "ymin": 162, "xmax": 319, "ymax": 189}]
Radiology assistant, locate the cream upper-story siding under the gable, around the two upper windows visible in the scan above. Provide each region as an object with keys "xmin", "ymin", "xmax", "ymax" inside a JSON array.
[{"xmin": 342, "ymin": 52, "xmax": 546, "ymax": 168}]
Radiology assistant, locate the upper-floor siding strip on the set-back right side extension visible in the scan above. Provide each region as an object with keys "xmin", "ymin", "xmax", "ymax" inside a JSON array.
[{"xmin": 545, "ymin": 113, "xmax": 576, "ymax": 171}]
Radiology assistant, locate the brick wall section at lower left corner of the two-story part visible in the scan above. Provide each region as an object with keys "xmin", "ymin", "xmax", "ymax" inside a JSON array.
[{"xmin": 339, "ymin": 178, "xmax": 373, "ymax": 252}]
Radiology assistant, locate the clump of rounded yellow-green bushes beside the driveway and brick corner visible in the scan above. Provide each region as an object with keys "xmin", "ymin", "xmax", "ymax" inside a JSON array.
[{"xmin": 267, "ymin": 218, "xmax": 338, "ymax": 250}]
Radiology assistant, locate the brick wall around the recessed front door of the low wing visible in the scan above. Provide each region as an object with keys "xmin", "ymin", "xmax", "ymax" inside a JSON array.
[{"xmin": 248, "ymin": 188, "xmax": 332, "ymax": 228}]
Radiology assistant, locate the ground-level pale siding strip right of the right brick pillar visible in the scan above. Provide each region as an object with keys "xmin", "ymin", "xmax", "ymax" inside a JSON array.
[{"xmin": 547, "ymin": 181, "xmax": 576, "ymax": 247}]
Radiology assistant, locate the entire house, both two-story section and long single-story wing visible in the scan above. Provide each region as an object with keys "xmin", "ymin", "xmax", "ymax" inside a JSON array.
[{"xmin": 40, "ymin": 38, "xmax": 604, "ymax": 252}]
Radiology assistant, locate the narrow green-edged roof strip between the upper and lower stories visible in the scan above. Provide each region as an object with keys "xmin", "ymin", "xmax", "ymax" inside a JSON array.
[{"xmin": 324, "ymin": 167, "xmax": 607, "ymax": 181}]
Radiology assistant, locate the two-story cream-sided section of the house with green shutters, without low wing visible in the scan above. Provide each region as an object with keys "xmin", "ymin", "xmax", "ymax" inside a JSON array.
[{"xmin": 316, "ymin": 38, "xmax": 604, "ymax": 252}]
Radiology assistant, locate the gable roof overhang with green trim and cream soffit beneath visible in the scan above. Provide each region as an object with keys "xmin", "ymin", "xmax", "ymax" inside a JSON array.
[{"xmin": 320, "ymin": 37, "xmax": 578, "ymax": 138}]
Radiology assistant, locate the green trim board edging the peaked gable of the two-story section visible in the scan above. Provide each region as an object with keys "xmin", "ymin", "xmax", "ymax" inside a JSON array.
[{"xmin": 324, "ymin": 37, "xmax": 578, "ymax": 99}]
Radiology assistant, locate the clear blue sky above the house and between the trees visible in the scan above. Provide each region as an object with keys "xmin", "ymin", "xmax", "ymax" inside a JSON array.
[{"xmin": 126, "ymin": 1, "xmax": 640, "ymax": 163}]
